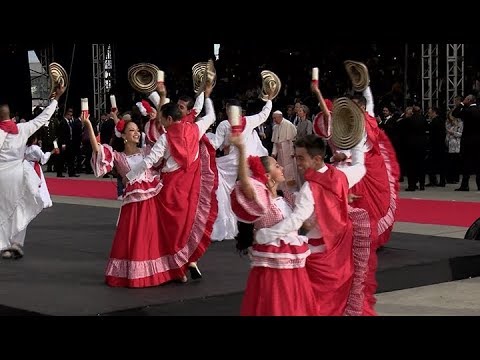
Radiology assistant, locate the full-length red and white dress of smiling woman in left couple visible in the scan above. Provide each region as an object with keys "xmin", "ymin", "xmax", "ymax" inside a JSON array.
[{"xmin": 92, "ymin": 144, "xmax": 173, "ymax": 288}]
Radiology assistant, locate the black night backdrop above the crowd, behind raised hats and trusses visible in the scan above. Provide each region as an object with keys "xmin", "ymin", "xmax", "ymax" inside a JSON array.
[{"xmin": 0, "ymin": 39, "xmax": 480, "ymax": 118}]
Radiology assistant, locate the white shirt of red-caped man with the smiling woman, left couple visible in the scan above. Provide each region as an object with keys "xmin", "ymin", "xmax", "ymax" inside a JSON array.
[{"xmin": 126, "ymin": 98, "xmax": 215, "ymax": 181}]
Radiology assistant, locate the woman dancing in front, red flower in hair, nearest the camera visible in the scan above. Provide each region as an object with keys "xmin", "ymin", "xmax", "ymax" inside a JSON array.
[{"xmin": 231, "ymin": 136, "xmax": 318, "ymax": 316}]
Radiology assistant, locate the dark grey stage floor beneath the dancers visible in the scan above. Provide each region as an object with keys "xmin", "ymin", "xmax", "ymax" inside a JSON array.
[{"xmin": 0, "ymin": 200, "xmax": 480, "ymax": 315}]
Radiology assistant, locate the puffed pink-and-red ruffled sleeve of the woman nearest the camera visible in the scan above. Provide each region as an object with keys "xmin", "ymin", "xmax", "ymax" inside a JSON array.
[{"xmin": 230, "ymin": 178, "xmax": 271, "ymax": 223}]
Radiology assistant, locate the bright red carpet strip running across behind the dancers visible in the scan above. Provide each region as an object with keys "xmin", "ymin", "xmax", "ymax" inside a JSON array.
[{"xmin": 46, "ymin": 178, "xmax": 480, "ymax": 227}]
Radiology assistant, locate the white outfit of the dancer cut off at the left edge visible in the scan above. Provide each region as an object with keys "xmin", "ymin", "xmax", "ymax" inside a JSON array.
[{"xmin": 0, "ymin": 100, "xmax": 57, "ymax": 251}]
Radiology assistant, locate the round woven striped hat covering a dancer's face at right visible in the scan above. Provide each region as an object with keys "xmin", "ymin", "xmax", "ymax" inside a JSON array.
[{"xmin": 332, "ymin": 97, "xmax": 365, "ymax": 150}]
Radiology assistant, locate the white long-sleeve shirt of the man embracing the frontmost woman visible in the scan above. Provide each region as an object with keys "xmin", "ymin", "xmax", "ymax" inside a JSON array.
[{"xmin": 255, "ymin": 145, "xmax": 366, "ymax": 244}]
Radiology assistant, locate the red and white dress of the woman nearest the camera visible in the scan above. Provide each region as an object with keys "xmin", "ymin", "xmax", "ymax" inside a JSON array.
[{"xmin": 231, "ymin": 179, "xmax": 318, "ymax": 316}]
